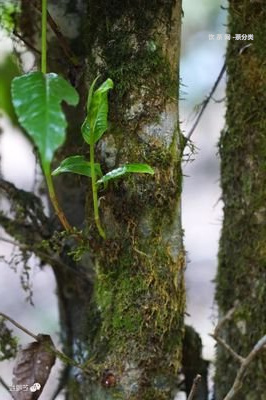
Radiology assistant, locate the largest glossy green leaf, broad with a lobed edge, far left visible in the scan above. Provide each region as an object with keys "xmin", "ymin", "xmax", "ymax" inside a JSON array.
[{"xmin": 11, "ymin": 72, "xmax": 79, "ymax": 173}]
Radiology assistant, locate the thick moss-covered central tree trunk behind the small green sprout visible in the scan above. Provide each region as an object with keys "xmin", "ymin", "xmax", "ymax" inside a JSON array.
[{"xmin": 79, "ymin": 1, "xmax": 184, "ymax": 400}]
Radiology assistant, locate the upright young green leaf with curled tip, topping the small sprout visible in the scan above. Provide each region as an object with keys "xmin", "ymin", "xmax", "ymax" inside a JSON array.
[{"xmin": 81, "ymin": 77, "xmax": 114, "ymax": 145}]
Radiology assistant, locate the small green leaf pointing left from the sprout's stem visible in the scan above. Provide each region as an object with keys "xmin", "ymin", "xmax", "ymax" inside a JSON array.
[{"xmin": 52, "ymin": 156, "xmax": 103, "ymax": 177}]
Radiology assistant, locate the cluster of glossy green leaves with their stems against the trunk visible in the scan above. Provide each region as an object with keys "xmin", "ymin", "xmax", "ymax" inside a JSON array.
[{"xmin": 11, "ymin": 72, "xmax": 154, "ymax": 238}]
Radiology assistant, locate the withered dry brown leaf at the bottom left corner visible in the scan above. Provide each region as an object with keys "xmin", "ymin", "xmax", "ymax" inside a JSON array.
[{"xmin": 10, "ymin": 335, "xmax": 55, "ymax": 400}]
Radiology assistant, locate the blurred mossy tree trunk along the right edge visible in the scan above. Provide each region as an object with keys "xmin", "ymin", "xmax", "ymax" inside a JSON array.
[{"xmin": 216, "ymin": 0, "xmax": 266, "ymax": 400}]
